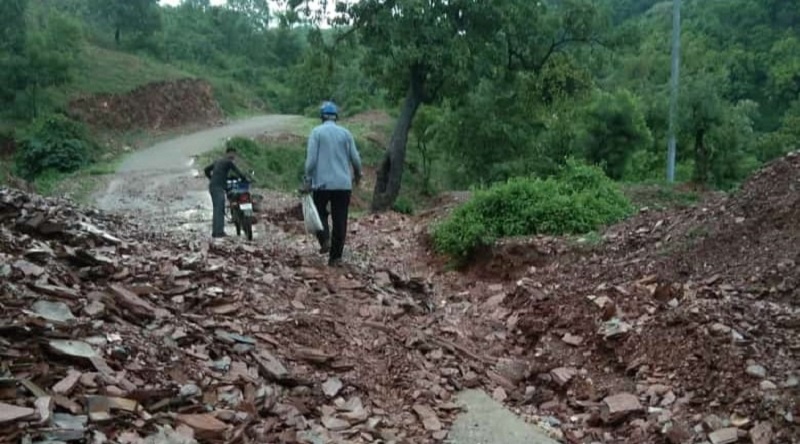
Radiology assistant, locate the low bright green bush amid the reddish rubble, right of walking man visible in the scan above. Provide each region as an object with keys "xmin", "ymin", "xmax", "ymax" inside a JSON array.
[{"xmin": 433, "ymin": 159, "xmax": 632, "ymax": 262}]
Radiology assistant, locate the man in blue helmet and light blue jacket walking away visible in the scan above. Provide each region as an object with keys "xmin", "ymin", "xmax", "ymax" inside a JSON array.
[{"xmin": 304, "ymin": 102, "xmax": 361, "ymax": 266}]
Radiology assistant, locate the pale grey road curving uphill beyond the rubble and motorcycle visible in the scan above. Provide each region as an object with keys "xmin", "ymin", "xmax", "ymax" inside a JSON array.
[{"xmin": 94, "ymin": 115, "xmax": 302, "ymax": 234}]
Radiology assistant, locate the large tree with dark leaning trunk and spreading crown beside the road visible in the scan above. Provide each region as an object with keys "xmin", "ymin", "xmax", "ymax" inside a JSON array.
[{"xmin": 322, "ymin": 0, "xmax": 594, "ymax": 211}]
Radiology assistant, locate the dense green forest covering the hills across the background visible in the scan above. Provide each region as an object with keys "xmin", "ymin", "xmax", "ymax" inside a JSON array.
[{"xmin": 0, "ymin": 0, "xmax": 800, "ymax": 209}]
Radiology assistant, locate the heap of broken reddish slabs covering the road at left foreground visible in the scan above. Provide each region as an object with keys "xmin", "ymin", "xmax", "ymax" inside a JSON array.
[{"xmin": 0, "ymin": 188, "xmax": 492, "ymax": 443}]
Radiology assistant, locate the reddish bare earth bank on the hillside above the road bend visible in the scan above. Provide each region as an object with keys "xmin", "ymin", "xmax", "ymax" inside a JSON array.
[{"xmin": 68, "ymin": 79, "xmax": 222, "ymax": 131}]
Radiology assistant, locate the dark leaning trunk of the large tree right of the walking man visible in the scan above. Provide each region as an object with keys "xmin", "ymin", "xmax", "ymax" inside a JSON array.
[{"xmin": 372, "ymin": 85, "xmax": 422, "ymax": 212}]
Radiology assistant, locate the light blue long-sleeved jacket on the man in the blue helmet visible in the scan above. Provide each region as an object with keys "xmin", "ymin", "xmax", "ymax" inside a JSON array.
[{"xmin": 305, "ymin": 120, "xmax": 361, "ymax": 190}]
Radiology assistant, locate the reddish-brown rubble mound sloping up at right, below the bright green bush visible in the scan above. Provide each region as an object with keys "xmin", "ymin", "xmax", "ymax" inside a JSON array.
[{"xmin": 495, "ymin": 153, "xmax": 800, "ymax": 443}]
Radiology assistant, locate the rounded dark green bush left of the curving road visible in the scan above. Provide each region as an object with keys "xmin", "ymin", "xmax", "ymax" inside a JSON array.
[{"xmin": 15, "ymin": 114, "xmax": 97, "ymax": 180}]
